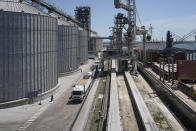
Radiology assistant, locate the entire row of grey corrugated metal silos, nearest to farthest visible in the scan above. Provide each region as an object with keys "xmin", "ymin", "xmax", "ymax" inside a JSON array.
[{"xmin": 0, "ymin": 0, "xmax": 103, "ymax": 102}]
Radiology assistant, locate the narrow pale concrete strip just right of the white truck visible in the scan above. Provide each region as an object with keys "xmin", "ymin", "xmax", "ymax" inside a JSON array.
[{"xmin": 72, "ymin": 78, "xmax": 100, "ymax": 131}]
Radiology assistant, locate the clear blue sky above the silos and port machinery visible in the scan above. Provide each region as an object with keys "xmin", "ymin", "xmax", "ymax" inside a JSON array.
[{"xmin": 45, "ymin": 0, "xmax": 196, "ymax": 39}]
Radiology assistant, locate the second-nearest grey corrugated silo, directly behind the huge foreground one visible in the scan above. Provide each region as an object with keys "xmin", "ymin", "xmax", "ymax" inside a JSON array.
[{"xmin": 58, "ymin": 18, "xmax": 79, "ymax": 74}]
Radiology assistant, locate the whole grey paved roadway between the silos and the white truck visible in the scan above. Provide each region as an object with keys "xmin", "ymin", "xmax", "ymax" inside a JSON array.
[{"xmin": 0, "ymin": 61, "xmax": 92, "ymax": 131}]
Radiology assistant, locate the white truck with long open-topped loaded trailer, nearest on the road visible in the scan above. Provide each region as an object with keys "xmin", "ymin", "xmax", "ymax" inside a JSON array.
[{"xmin": 70, "ymin": 72, "xmax": 94, "ymax": 101}]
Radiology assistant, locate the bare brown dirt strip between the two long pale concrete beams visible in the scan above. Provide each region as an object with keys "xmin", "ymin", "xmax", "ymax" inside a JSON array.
[{"xmin": 117, "ymin": 75, "xmax": 139, "ymax": 131}]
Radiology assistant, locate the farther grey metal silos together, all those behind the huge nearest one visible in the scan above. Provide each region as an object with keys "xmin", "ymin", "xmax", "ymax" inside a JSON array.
[{"xmin": 54, "ymin": 15, "xmax": 88, "ymax": 74}]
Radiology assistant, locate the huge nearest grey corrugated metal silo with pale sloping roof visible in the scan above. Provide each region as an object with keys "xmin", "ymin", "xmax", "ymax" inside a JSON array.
[{"xmin": 0, "ymin": 0, "xmax": 58, "ymax": 102}]
